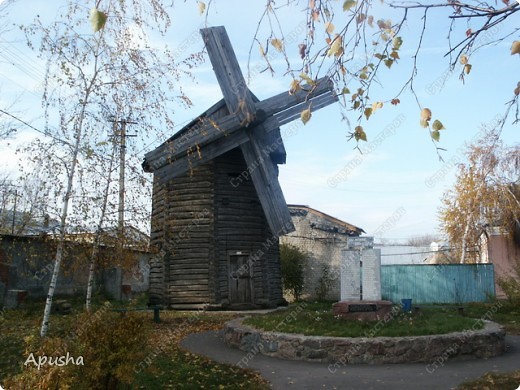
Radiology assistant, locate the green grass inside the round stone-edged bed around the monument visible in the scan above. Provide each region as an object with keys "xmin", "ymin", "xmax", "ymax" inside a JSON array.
[{"xmin": 245, "ymin": 303, "xmax": 488, "ymax": 337}]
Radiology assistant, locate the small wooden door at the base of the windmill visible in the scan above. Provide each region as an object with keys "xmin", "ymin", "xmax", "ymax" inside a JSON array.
[{"xmin": 228, "ymin": 253, "xmax": 253, "ymax": 304}]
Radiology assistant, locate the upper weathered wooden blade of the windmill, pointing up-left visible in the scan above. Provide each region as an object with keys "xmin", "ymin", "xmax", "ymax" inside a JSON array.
[{"xmin": 200, "ymin": 26, "xmax": 256, "ymax": 127}]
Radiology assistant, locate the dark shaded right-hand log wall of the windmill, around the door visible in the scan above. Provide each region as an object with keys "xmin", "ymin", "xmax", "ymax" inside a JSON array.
[{"xmin": 215, "ymin": 148, "xmax": 282, "ymax": 305}]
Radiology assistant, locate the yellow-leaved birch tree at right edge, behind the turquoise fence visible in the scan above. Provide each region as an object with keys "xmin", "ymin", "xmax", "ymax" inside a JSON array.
[{"xmin": 440, "ymin": 131, "xmax": 520, "ymax": 264}]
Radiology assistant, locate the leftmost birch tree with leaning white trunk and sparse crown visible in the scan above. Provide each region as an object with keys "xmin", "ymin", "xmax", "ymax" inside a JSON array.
[{"xmin": 22, "ymin": 0, "xmax": 190, "ymax": 336}]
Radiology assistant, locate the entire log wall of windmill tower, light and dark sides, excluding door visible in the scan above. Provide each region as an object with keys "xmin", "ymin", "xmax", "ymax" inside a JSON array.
[{"xmin": 150, "ymin": 148, "xmax": 283, "ymax": 308}]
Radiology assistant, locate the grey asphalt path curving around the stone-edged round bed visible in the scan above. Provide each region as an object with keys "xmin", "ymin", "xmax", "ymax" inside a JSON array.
[{"xmin": 181, "ymin": 331, "xmax": 520, "ymax": 390}]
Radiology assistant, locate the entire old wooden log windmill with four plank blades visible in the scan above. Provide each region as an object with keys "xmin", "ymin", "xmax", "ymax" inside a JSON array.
[{"xmin": 143, "ymin": 27, "xmax": 337, "ymax": 309}]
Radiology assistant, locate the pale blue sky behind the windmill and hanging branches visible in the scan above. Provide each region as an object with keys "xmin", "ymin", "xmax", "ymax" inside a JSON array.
[{"xmin": 0, "ymin": 0, "xmax": 520, "ymax": 240}]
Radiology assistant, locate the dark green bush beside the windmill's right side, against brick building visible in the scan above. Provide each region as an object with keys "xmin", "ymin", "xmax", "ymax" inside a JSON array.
[{"xmin": 280, "ymin": 244, "xmax": 305, "ymax": 301}]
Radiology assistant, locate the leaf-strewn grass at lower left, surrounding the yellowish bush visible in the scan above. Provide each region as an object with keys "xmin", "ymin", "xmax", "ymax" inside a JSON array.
[{"xmin": 0, "ymin": 301, "xmax": 269, "ymax": 389}]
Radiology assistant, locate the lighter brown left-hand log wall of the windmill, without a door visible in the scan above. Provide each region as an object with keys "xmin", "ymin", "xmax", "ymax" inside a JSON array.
[{"xmin": 152, "ymin": 162, "xmax": 215, "ymax": 307}]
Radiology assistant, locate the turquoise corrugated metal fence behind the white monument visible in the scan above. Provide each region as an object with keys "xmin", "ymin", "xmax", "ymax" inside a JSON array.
[{"xmin": 381, "ymin": 264, "xmax": 495, "ymax": 303}]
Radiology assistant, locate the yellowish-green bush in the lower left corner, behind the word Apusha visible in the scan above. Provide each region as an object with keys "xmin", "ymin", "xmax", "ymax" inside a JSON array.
[{"xmin": 6, "ymin": 307, "xmax": 151, "ymax": 389}]
